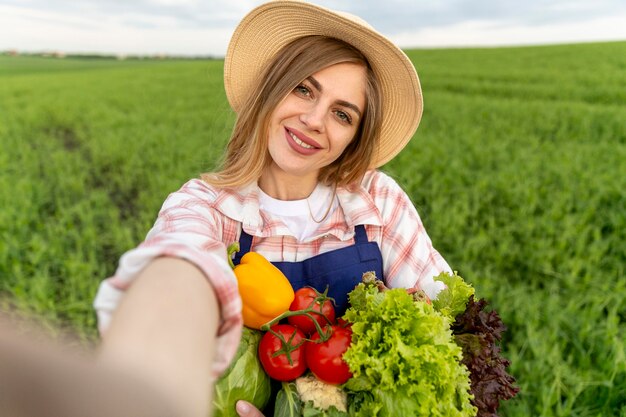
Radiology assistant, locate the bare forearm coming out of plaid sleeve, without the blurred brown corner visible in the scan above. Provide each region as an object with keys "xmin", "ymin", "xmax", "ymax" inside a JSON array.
[{"xmin": 99, "ymin": 257, "xmax": 220, "ymax": 417}]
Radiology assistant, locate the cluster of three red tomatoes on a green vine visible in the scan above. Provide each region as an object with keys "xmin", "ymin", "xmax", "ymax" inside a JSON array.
[{"xmin": 259, "ymin": 287, "xmax": 352, "ymax": 385}]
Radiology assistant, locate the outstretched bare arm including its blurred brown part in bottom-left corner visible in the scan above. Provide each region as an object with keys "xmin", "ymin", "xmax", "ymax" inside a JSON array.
[{"xmin": 0, "ymin": 257, "xmax": 219, "ymax": 417}]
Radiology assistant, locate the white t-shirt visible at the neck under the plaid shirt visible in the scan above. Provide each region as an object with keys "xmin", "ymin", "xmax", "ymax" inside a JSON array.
[{"xmin": 259, "ymin": 184, "xmax": 339, "ymax": 241}]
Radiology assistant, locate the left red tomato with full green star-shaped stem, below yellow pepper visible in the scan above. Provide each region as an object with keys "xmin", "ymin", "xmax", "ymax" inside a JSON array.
[{"xmin": 259, "ymin": 324, "xmax": 307, "ymax": 381}]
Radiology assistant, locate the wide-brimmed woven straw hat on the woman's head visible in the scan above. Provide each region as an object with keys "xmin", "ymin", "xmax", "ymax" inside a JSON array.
[{"xmin": 224, "ymin": 0, "xmax": 422, "ymax": 168}]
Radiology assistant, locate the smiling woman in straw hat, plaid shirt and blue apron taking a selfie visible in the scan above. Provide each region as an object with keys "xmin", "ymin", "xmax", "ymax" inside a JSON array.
[{"xmin": 94, "ymin": 1, "xmax": 450, "ymax": 415}]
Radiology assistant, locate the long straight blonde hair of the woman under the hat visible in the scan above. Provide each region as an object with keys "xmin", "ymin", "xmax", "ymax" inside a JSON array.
[{"xmin": 202, "ymin": 36, "xmax": 383, "ymax": 188}]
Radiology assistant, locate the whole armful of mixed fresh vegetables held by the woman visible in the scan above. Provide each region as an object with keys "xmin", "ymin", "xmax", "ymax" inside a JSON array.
[{"xmin": 214, "ymin": 248, "xmax": 518, "ymax": 417}]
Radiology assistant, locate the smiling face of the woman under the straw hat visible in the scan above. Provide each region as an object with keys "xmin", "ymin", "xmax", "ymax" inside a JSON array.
[{"xmin": 268, "ymin": 63, "xmax": 367, "ymax": 187}]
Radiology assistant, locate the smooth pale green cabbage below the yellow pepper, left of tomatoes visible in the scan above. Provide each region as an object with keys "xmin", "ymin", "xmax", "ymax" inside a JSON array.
[{"xmin": 213, "ymin": 327, "xmax": 271, "ymax": 417}]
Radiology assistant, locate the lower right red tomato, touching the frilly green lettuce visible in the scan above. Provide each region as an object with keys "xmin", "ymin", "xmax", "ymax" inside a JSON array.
[{"xmin": 305, "ymin": 326, "xmax": 352, "ymax": 385}]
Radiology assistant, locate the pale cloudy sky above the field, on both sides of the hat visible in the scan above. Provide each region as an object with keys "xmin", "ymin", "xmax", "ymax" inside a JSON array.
[{"xmin": 0, "ymin": 0, "xmax": 626, "ymax": 57}]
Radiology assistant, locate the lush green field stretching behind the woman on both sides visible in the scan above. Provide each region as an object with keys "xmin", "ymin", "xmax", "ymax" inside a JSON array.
[{"xmin": 0, "ymin": 42, "xmax": 626, "ymax": 417}]
